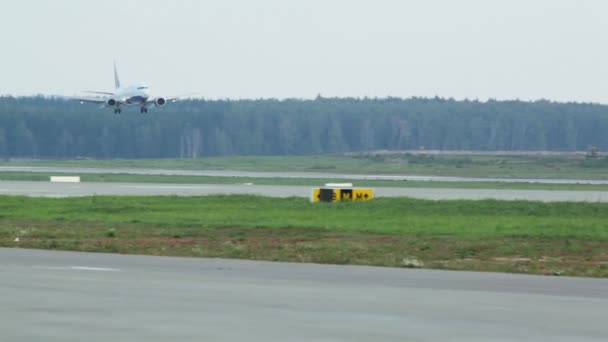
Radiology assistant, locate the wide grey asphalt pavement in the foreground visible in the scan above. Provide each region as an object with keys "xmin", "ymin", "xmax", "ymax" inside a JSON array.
[{"xmin": 0, "ymin": 249, "xmax": 608, "ymax": 342}]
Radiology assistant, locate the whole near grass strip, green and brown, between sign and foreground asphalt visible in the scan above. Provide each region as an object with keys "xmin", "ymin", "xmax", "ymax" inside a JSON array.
[{"xmin": 0, "ymin": 195, "xmax": 608, "ymax": 277}]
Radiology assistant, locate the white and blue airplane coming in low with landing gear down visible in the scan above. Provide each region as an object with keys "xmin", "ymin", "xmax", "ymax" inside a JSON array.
[{"xmin": 73, "ymin": 62, "xmax": 185, "ymax": 114}]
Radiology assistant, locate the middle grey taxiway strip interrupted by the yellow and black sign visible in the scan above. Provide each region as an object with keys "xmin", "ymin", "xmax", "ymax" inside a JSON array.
[{"xmin": 0, "ymin": 181, "xmax": 608, "ymax": 202}]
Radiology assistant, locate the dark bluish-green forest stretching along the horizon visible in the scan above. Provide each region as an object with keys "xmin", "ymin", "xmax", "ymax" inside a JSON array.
[{"xmin": 0, "ymin": 96, "xmax": 608, "ymax": 159}]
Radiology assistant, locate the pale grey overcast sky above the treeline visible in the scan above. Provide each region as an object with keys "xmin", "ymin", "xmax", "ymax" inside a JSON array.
[{"xmin": 0, "ymin": 0, "xmax": 608, "ymax": 103}]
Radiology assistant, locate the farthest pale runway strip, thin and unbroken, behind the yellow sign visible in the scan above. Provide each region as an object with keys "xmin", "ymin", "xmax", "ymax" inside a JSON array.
[{"xmin": 0, "ymin": 166, "xmax": 608, "ymax": 184}]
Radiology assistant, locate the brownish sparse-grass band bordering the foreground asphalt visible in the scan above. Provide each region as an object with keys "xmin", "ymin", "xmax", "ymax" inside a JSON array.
[{"xmin": 0, "ymin": 225, "xmax": 608, "ymax": 277}]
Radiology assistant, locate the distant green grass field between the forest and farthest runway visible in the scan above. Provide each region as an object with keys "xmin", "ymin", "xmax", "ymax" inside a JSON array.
[{"xmin": 0, "ymin": 152, "xmax": 608, "ymax": 179}]
